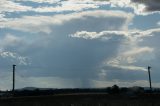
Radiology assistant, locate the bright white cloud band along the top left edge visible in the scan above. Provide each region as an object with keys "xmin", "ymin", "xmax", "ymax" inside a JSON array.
[{"xmin": 0, "ymin": 0, "xmax": 99, "ymax": 14}]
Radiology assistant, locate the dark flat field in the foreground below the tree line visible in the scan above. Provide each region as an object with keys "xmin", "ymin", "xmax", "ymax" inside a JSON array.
[{"xmin": 0, "ymin": 93, "xmax": 160, "ymax": 106}]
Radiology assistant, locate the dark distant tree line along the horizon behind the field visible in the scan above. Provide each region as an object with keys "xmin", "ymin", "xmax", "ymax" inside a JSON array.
[{"xmin": 0, "ymin": 85, "xmax": 160, "ymax": 97}]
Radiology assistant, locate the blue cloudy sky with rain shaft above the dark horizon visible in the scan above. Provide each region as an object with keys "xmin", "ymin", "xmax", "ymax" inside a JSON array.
[{"xmin": 0, "ymin": 0, "xmax": 160, "ymax": 90}]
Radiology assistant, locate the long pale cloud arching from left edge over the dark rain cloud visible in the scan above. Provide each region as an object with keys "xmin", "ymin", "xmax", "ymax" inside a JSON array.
[{"xmin": 0, "ymin": 10, "xmax": 133, "ymax": 34}]
